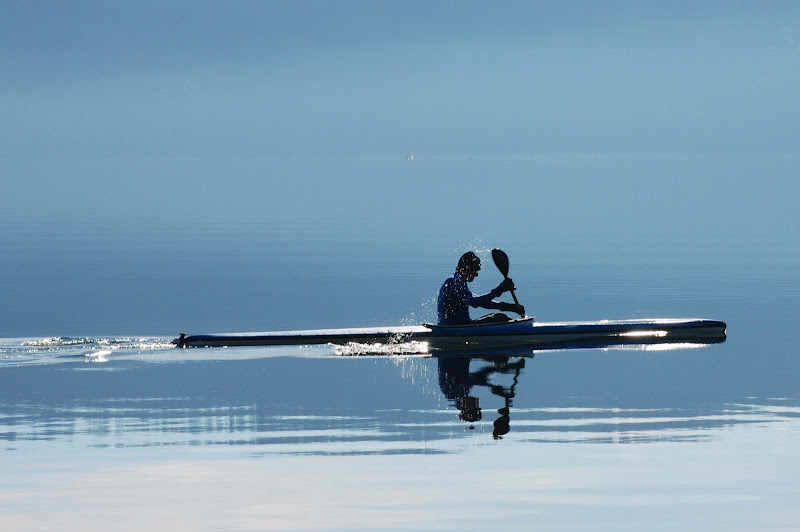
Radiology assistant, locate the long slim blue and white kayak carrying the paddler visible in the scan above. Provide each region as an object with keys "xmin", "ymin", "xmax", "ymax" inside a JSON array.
[{"xmin": 172, "ymin": 318, "xmax": 726, "ymax": 349}]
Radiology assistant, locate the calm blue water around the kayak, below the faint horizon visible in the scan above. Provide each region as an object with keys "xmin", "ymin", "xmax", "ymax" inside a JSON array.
[{"xmin": 0, "ymin": 156, "xmax": 800, "ymax": 531}]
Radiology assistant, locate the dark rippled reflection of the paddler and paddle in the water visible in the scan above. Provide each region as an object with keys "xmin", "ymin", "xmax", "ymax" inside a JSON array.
[{"xmin": 438, "ymin": 356, "xmax": 525, "ymax": 439}]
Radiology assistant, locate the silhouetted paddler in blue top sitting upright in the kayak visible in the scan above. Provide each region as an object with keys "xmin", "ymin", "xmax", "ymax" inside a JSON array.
[{"xmin": 437, "ymin": 251, "xmax": 525, "ymax": 325}]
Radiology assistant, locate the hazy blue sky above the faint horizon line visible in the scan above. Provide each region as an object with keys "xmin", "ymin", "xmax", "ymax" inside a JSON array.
[{"xmin": 0, "ymin": 1, "xmax": 800, "ymax": 156}]
